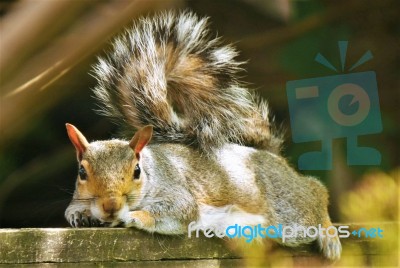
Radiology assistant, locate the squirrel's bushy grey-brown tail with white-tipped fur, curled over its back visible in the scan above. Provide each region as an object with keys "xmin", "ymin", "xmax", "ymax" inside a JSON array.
[{"xmin": 94, "ymin": 12, "xmax": 280, "ymax": 152}]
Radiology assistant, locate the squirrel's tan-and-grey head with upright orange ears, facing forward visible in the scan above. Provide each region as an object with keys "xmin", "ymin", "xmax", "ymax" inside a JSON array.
[{"xmin": 66, "ymin": 124, "xmax": 153, "ymax": 224}]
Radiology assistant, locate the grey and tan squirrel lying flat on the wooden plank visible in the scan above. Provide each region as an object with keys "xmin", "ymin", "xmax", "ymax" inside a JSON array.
[{"xmin": 65, "ymin": 12, "xmax": 341, "ymax": 260}]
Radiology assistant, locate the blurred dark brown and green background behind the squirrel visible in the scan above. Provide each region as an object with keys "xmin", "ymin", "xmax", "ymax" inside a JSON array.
[{"xmin": 0, "ymin": 0, "xmax": 400, "ymax": 227}]
